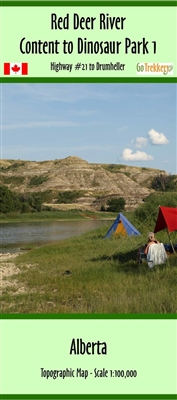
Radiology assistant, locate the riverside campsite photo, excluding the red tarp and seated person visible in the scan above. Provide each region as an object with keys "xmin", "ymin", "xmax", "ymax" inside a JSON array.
[{"xmin": 0, "ymin": 83, "xmax": 177, "ymax": 314}]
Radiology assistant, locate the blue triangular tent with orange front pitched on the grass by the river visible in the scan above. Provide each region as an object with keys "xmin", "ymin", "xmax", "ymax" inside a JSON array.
[{"xmin": 105, "ymin": 213, "xmax": 141, "ymax": 238}]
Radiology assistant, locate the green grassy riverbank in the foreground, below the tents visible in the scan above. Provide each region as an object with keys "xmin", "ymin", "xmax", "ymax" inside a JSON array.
[{"xmin": 1, "ymin": 224, "xmax": 177, "ymax": 314}]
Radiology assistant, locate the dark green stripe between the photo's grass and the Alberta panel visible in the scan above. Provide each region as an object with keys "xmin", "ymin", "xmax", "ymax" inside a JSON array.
[{"xmin": 0, "ymin": 314, "xmax": 177, "ymax": 320}]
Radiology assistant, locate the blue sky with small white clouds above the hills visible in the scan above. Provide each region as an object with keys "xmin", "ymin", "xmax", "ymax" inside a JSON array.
[{"xmin": 1, "ymin": 83, "xmax": 177, "ymax": 174}]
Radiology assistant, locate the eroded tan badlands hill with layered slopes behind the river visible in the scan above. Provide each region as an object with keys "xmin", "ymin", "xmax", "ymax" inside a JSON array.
[{"xmin": 0, "ymin": 157, "xmax": 168, "ymax": 210}]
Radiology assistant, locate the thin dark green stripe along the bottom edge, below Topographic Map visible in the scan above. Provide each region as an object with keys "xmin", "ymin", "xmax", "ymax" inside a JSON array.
[{"xmin": 0, "ymin": 394, "xmax": 177, "ymax": 400}]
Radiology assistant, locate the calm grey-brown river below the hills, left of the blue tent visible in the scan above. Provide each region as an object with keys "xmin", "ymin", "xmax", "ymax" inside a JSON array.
[{"xmin": 0, "ymin": 220, "xmax": 111, "ymax": 253}]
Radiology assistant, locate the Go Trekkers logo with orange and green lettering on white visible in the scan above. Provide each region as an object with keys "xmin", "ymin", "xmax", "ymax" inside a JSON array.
[{"xmin": 136, "ymin": 63, "xmax": 173, "ymax": 75}]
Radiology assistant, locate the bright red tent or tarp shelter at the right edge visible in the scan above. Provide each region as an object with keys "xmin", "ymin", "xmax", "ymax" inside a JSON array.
[{"xmin": 154, "ymin": 206, "xmax": 177, "ymax": 233}]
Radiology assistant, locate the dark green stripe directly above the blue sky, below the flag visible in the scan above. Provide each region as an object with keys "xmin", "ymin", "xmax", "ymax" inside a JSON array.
[{"xmin": 0, "ymin": 76, "xmax": 177, "ymax": 83}]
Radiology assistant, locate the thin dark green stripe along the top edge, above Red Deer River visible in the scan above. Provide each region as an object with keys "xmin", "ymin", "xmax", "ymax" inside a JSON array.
[{"xmin": 0, "ymin": 0, "xmax": 177, "ymax": 7}]
